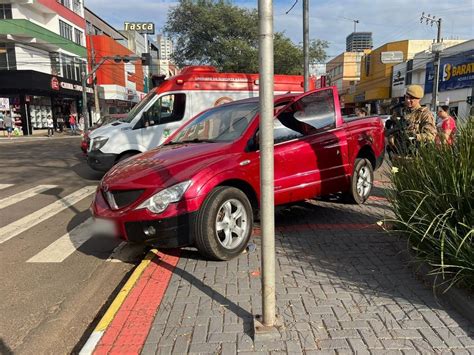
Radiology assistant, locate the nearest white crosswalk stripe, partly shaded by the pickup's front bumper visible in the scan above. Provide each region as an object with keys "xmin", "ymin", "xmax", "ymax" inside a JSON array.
[{"xmin": 27, "ymin": 218, "xmax": 94, "ymax": 263}]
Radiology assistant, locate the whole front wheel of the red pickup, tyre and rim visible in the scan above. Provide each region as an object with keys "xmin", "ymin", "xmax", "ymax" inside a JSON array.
[{"xmin": 194, "ymin": 186, "xmax": 253, "ymax": 260}]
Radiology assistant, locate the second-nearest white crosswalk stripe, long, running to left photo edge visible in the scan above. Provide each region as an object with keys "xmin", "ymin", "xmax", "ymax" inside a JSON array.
[{"xmin": 0, "ymin": 186, "xmax": 96, "ymax": 244}]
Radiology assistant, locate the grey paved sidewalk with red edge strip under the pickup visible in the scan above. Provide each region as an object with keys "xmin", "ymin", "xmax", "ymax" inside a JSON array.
[{"xmin": 81, "ymin": 171, "xmax": 474, "ymax": 354}]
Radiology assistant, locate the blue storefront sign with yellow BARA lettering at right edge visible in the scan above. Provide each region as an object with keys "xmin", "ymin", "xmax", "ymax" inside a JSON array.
[{"xmin": 425, "ymin": 50, "xmax": 474, "ymax": 93}]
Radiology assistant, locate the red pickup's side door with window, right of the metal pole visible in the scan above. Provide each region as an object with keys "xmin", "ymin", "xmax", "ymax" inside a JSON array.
[{"xmin": 274, "ymin": 89, "xmax": 347, "ymax": 200}]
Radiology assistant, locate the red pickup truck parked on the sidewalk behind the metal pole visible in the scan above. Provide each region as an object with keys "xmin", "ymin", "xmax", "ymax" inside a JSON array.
[{"xmin": 92, "ymin": 87, "xmax": 385, "ymax": 260}]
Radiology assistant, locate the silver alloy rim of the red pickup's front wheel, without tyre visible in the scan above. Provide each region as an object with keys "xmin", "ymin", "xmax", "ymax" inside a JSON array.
[{"xmin": 216, "ymin": 199, "xmax": 248, "ymax": 249}]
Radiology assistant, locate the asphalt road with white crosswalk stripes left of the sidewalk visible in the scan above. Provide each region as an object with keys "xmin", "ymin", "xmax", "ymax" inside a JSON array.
[{"xmin": 0, "ymin": 136, "xmax": 144, "ymax": 354}]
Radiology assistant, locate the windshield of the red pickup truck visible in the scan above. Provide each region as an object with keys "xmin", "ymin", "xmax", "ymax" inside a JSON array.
[{"xmin": 170, "ymin": 101, "xmax": 259, "ymax": 144}]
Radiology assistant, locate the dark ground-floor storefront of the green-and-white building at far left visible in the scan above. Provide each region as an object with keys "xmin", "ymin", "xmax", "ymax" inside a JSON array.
[{"xmin": 0, "ymin": 70, "xmax": 93, "ymax": 135}]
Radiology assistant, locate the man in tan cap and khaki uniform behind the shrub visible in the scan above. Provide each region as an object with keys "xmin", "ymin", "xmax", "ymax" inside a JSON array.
[{"xmin": 386, "ymin": 85, "xmax": 436, "ymax": 155}]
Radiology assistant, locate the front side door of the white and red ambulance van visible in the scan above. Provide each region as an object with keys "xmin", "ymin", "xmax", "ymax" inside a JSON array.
[{"xmin": 135, "ymin": 93, "xmax": 189, "ymax": 150}]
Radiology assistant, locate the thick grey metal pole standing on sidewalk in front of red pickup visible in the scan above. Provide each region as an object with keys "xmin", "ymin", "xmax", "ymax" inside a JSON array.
[{"xmin": 258, "ymin": 0, "xmax": 275, "ymax": 327}]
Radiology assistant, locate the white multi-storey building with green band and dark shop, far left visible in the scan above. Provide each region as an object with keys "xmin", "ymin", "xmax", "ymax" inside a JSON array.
[{"xmin": 0, "ymin": 0, "xmax": 92, "ymax": 134}]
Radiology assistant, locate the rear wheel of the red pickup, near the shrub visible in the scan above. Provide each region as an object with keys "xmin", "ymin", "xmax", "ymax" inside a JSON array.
[{"xmin": 348, "ymin": 158, "xmax": 374, "ymax": 205}]
